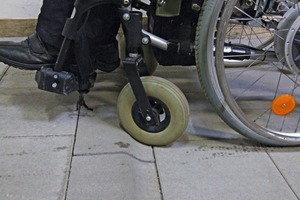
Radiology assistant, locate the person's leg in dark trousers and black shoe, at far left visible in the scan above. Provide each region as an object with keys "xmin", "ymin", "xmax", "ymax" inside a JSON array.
[{"xmin": 0, "ymin": 0, "xmax": 74, "ymax": 70}]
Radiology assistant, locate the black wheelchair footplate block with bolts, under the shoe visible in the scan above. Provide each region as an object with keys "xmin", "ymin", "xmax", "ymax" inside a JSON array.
[{"xmin": 35, "ymin": 67, "xmax": 79, "ymax": 95}]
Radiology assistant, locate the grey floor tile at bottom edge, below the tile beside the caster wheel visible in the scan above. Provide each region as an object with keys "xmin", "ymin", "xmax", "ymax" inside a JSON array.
[{"xmin": 67, "ymin": 154, "xmax": 161, "ymax": 200}]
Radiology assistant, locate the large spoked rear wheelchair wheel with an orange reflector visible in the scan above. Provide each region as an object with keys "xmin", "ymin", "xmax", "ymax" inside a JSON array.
[{"xmin": 196, "ymin": 0, "xmax": 300, "ymax": 146}]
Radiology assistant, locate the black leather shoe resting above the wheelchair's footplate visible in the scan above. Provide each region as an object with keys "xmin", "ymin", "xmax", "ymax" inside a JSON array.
[{"xmin": 0, "ymin": 33, "xmax": 56, "ymax": 70}]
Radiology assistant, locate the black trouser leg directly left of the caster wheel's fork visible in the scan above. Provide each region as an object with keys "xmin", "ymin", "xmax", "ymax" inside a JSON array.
[{"xmin": 85, "ymin": 5, "xmax": 120, "ymax": 72}]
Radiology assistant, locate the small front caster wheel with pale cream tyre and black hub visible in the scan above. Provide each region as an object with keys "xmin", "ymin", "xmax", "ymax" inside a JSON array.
[{"xmin": 117, "ymin": 76, "xmax": 189, "ymax": 146}]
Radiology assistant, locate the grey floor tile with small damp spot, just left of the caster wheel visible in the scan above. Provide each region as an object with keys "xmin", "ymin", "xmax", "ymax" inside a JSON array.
[{"xmin": 74, "ymin": 70, "xmax": 154, "ymax": 161}]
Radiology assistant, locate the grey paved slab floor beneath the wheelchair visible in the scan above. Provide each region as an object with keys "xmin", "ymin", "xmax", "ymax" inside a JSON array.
[{"xmin": 0, "ymin": 64, "xmax": 300, "ymax": 200}]
